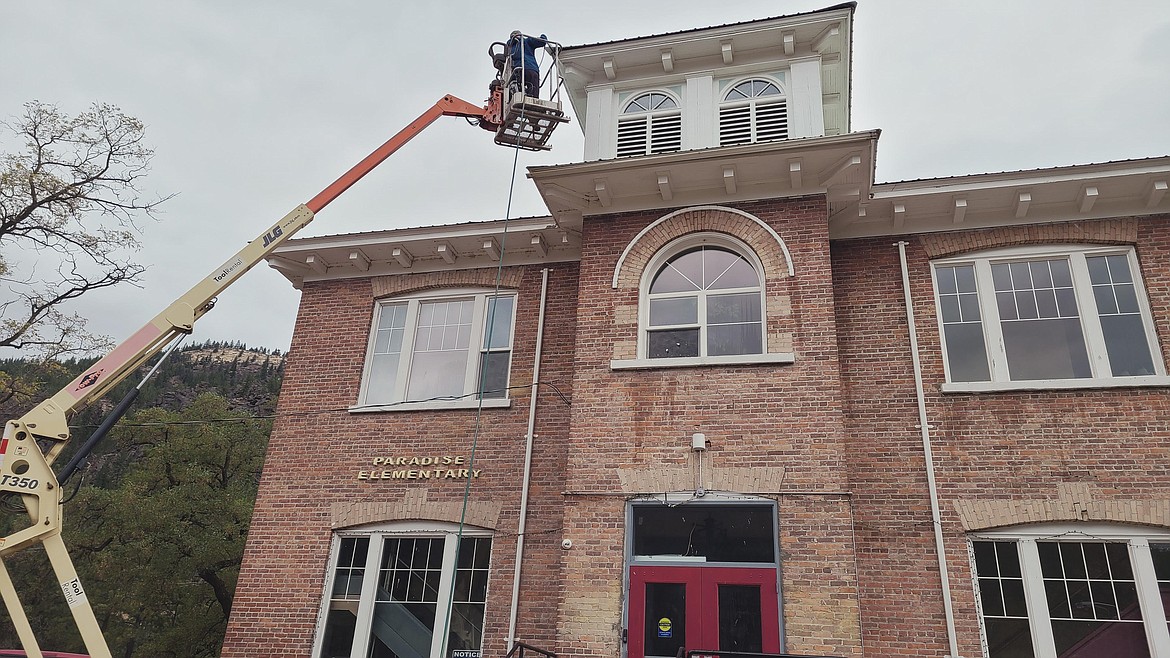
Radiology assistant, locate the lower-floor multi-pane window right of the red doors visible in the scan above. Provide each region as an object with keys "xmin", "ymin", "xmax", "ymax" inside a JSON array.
[{"xmin": 971, "ymin": 525, "xmax": 1170, "ymax": 658}]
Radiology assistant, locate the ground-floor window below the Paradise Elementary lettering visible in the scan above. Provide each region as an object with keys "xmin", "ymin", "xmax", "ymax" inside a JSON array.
[{"xmin": 315, "ymin": 522, "xmax": 491, "ymax": 658}]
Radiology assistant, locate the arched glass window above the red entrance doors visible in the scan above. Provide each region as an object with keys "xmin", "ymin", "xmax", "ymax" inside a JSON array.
[{"xmin": 642, "ymin": 235, "xmax": 764, "ymax": 358}]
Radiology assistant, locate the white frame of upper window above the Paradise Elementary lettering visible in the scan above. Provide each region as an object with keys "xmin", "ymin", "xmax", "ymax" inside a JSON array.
[{"xmin": 349, "ymin": 288, "xmax": 517, "ymax": 412}]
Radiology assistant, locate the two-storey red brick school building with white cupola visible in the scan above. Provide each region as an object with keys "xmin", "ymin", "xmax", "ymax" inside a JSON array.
[{"xmin": 223, "ymin": 5, "xmax": 1170, "ymax": 658}]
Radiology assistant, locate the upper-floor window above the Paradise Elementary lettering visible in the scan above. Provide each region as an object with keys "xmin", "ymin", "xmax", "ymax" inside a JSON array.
[{"xmin": 362, "ymin": 290, "xmax": 516, "ymax": 406}]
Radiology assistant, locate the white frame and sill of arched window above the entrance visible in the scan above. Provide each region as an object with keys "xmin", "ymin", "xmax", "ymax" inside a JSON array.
[{"xmin": 610, "ymin": 232, "xmax": 794, "ymax": 370}]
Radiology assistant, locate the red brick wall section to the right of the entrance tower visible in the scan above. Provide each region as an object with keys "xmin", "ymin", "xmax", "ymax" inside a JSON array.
[{"xmin": 832, "ymin": 213, "xmax": 1170, "ymax": 657}]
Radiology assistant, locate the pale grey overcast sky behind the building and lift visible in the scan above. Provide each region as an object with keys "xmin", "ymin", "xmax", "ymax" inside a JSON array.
[{"xmin": 0, "ymin": 0, "xmax": 1170, "ymax": 356}]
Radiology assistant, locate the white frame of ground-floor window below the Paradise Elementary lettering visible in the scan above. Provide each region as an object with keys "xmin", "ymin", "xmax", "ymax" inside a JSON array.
[{"xmin": 312, "ymin": 521, "xmax": 496, "ymax": 658}]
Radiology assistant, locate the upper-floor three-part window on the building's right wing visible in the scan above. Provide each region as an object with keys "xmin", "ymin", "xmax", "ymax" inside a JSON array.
[{"xmin": 934, "ymin": 247, "xmax": 1164, "ymax": 389}]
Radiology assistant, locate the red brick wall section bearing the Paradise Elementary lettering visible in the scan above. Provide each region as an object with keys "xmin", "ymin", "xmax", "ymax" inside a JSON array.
[{"xmin": 222, "ymin": 263, "xmax": 577, "ymax": 658}]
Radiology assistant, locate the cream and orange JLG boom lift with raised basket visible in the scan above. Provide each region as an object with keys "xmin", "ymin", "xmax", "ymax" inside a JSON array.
[{"xmin": 0, "ymin": 37, "xmax": 569, "ymax": 658}]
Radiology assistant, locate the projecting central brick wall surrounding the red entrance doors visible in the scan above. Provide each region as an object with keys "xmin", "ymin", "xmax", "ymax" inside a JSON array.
[{"xmin": 558, "ymin": 197, "xmax": 860, "ymax": 657}]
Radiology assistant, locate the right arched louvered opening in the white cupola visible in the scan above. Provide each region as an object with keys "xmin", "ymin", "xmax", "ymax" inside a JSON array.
[{"xmin": 720, "ymin": 78, "xmax": 789, "ymax": 146}]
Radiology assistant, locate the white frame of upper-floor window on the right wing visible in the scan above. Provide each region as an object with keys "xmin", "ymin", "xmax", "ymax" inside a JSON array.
[{"xmin": 930, "ymin": 245, "xmax": 1170, "ymax": 392}]
